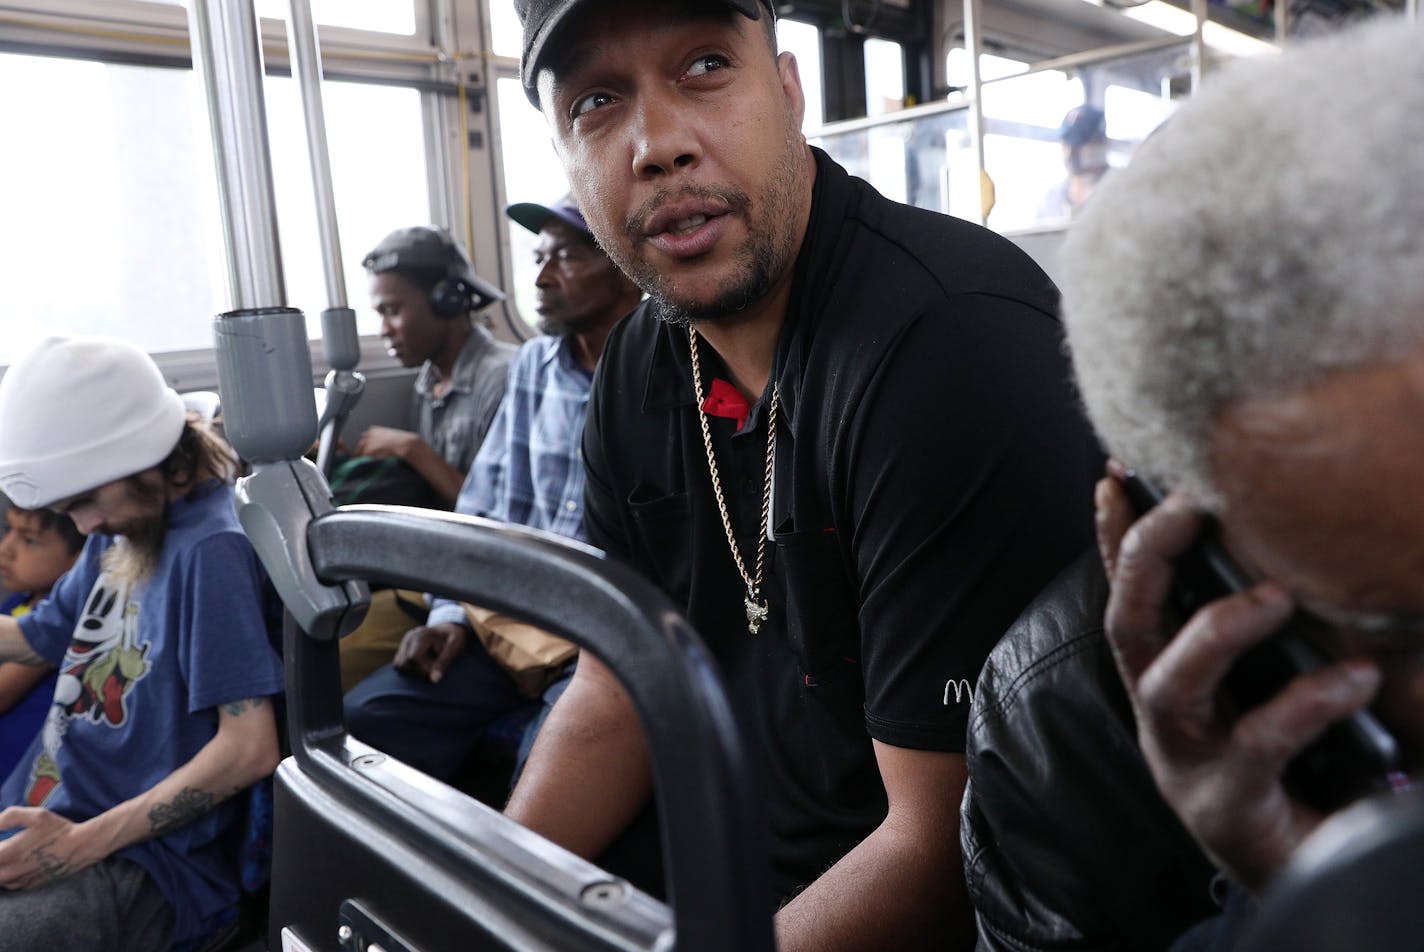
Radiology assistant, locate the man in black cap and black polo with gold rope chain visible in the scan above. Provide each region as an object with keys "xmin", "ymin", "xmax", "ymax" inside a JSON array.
[{"xmin": 508, "ymin": 0, "xmax": 1096, "ymax": 949}]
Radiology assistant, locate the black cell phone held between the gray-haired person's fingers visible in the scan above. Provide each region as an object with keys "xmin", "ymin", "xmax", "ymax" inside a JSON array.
[{"xmin": 1122, "ymin": 472, "xmax": 1404, "ymax": 813}]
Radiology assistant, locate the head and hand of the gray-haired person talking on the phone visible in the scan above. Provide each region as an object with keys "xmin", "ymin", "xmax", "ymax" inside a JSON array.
[{"xmin": 1064, "ymin": 18, "xmax": 1424, "ymax": 950}]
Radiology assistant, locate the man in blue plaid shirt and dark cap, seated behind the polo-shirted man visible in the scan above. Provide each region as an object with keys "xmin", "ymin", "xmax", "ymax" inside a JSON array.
[{"xmin": 346, "ymin": 196, "xmax": 641, "ymax": 781}]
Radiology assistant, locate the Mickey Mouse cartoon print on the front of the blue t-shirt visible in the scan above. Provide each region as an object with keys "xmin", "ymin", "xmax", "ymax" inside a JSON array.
[{"xmin": 24, "ymin": 572, "xmax": 150, "ymax": 807}]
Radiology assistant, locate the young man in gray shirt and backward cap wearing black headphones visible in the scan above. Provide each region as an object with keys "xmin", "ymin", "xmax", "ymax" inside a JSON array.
[{"xmin": 356, "ymin": 226, "xmax": 514, "ymax": 507}]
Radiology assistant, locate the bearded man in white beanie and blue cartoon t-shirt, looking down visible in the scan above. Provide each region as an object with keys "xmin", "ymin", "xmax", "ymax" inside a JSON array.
[{"xmin": 0, "ymin": 337, "xmax": 282, "ymax": 951}]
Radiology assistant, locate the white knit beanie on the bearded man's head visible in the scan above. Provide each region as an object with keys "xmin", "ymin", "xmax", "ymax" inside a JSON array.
[{"xmin": 0, "ymin": 337, "xmax": 184, "ymax": 509}]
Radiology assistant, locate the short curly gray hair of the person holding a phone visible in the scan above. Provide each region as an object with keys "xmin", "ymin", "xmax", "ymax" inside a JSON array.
[{"xmin": 1062, "ymin": 17, "xmax": 1424, "ymax": 508}]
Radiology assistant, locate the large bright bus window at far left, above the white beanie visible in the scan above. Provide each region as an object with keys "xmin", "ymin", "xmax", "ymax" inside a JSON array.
[{"xmin": 0, "ymin": 54, "xmax": 226, "ymax": 364}]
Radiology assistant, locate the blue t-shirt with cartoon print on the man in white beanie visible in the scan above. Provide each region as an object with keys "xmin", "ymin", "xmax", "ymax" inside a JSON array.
[{"xmin": 0, "ymin": 482, "xmax": 282, "ymax": 942}]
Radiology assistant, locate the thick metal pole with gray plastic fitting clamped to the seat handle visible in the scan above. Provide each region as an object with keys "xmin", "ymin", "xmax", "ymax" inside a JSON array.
[{"xmin": 188, "ymin": 0, "xmax": 367, "ymax": 643}]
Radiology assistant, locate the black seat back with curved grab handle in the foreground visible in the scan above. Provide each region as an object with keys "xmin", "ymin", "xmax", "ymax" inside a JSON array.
[{"xmin": 269, "ymin": 507, "xmax": 772, "ymax": 952}]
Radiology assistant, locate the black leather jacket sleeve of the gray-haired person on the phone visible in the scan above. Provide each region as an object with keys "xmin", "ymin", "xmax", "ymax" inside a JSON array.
[{"xmin": 961, "ymin": 552, "xmax": 1216, "ymax": 952}]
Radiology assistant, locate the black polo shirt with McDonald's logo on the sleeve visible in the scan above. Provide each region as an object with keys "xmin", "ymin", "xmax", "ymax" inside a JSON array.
[{"xmin": 584, "ymin": 149, "xmax": 1101, "ymax": 895}]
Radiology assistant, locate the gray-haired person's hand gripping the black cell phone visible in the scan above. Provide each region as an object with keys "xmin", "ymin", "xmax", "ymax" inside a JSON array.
[{"xmin": 1095, "ymin": 462, "xmax": 1380, "ymax": 894}]
